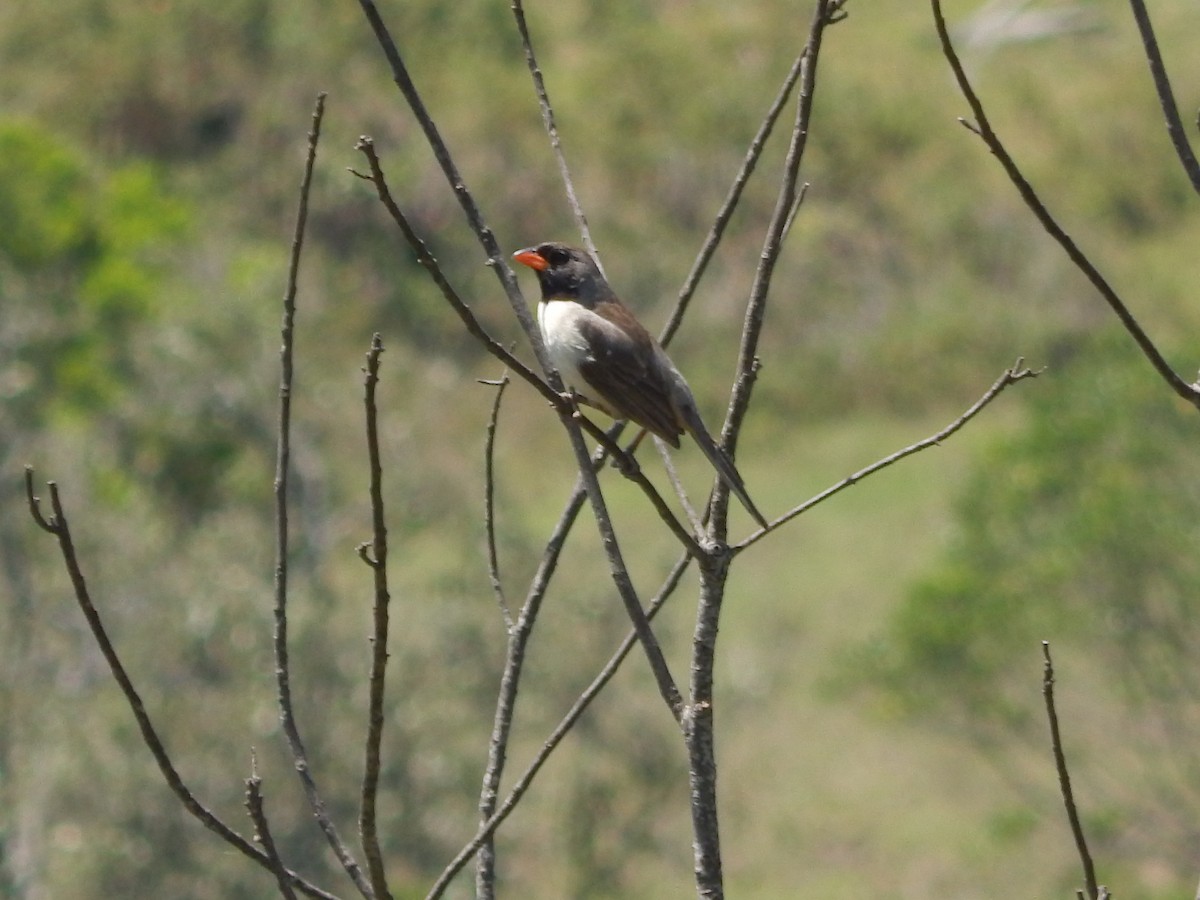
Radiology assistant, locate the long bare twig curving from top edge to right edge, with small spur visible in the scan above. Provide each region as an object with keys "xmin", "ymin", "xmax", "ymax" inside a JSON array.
[{"xmin": 930, "ymin": 0, "xmax": 1200, "ymax": 409}]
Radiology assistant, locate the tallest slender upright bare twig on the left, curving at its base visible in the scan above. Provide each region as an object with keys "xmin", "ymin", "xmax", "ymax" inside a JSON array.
[{"xmin": 274, "ymin": 94, "xmax": 371, "ymax": 896}]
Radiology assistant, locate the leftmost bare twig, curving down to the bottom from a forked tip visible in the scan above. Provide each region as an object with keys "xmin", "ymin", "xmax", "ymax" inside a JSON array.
[{"xmin": 25, "ymin": 466, "xmax": 337, "ymax": 900}]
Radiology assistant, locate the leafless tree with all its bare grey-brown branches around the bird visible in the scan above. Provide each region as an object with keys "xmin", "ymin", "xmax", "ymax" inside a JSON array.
[{"xmin": 26, "ymin": 0, "xmax": 1200, "ymax": 899}]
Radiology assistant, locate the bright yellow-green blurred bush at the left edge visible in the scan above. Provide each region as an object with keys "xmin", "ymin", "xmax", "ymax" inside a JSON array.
[{"xmin": 0, "ymin": 120, "xmax": 190, "ymax": 433}]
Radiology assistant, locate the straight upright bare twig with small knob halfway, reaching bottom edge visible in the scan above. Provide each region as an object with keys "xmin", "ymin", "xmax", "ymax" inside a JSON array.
[{"xmin": 359, "ymin": 334, "xmax": 391, "ymax": 899}]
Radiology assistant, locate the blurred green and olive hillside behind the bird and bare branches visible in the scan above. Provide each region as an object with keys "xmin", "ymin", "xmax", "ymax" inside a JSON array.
[{"xmin": 0, "ymin": 0, "xmax": 1200, "ymax": 900}]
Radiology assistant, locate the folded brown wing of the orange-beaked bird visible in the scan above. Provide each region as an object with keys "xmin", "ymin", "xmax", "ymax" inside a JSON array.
[{"xmin": 578, "ymin": 302, "xmax": 683, "ymax": 446}]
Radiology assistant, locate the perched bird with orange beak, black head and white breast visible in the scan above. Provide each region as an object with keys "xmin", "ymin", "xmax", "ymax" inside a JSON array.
[{"xmin": 512, "ymin": 241, "xmax": 769, "ymax": 528}]
